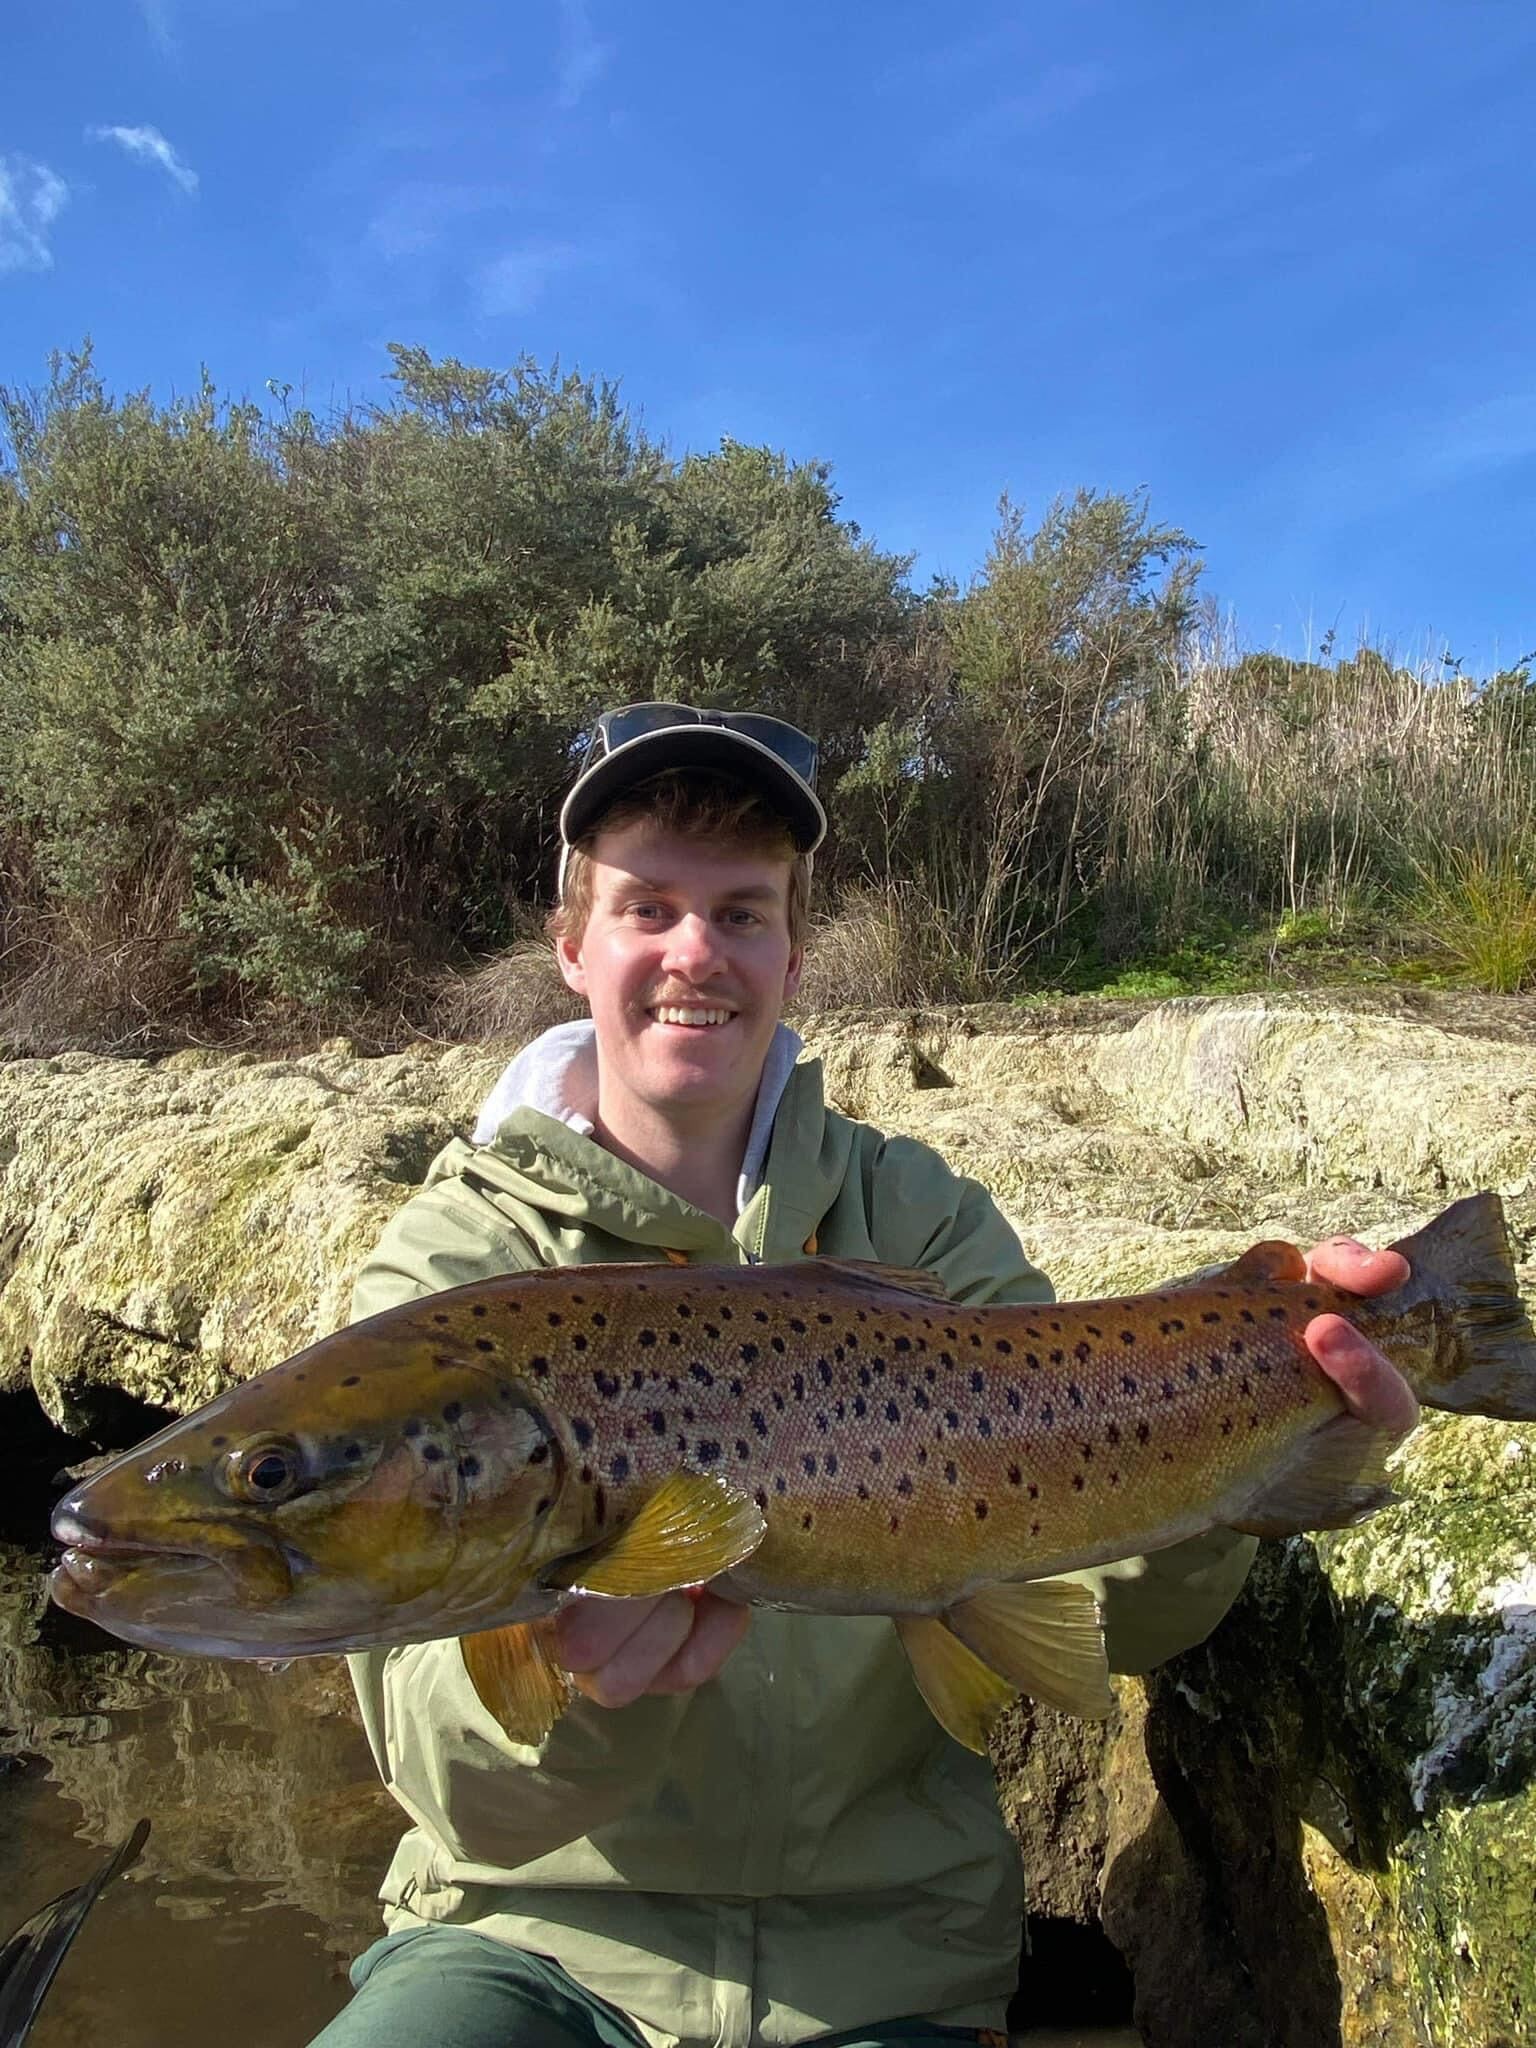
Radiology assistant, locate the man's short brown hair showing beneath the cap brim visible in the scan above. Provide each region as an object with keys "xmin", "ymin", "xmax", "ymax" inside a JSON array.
[{"xmin": 545, "ymin": 768, "xmax": 811, "ymax": 946}]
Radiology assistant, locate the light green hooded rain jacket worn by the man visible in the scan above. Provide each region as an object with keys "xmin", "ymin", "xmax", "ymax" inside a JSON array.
[{"xmin": 350, "ymin": 1061, "xmax": 1253, "ymax": 2048}]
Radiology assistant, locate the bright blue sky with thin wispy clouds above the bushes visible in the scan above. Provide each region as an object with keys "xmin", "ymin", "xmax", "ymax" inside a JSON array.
[{"xmin": 0, "ymin": 0, "xmax": 1536, "ymax": 670}]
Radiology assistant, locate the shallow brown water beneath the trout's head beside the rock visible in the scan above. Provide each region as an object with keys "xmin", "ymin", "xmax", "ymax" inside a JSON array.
[{"xmin": 0, "ymin": 1540, "xmax": 1139, "ymax": 2048}]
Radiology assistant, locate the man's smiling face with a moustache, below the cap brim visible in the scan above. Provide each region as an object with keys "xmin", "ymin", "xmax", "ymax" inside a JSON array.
[{"xmin": 557, "ymin": 819, "xmax": 801, "ymax": 1126}]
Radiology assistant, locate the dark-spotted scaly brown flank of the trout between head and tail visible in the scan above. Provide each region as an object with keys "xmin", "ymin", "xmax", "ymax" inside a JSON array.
[{"xmin": 405, "ymin": 1266, "xmax": 1346, "ymax": 1612}]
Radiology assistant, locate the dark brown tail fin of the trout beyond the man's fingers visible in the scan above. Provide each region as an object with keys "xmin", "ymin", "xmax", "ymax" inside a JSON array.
[{"xmin": 1391, "ymin": 1194, "xmax": 1536, "ymax": 1421}]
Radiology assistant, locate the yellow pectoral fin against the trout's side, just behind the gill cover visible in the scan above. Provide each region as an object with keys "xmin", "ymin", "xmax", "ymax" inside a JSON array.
[{"xmin": 545, "ymin": 1473, "xmax": 768, "ymax": 1599}]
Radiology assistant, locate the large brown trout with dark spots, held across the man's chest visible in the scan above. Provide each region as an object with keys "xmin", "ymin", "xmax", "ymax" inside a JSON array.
[{"xmin": 53, "ymin": 1194, "xmax": 1536, "ymax": 1747}]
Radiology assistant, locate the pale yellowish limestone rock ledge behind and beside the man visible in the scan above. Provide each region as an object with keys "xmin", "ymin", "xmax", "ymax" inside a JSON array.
[{"xmin": 0, "ymin": 995, "xmax": 1536, "ymax": 2048}]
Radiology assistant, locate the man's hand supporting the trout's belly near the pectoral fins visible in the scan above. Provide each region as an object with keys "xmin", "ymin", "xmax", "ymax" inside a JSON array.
[{"xmin": 555, "ymin": 1587, "xmax": 752, "ymax": 1706}]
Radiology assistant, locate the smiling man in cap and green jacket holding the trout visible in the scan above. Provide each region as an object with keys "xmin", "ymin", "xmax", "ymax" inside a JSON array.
[{"xmin": 309, "ymin": 705, "xmax": 1415, "ymax": 2048}]
